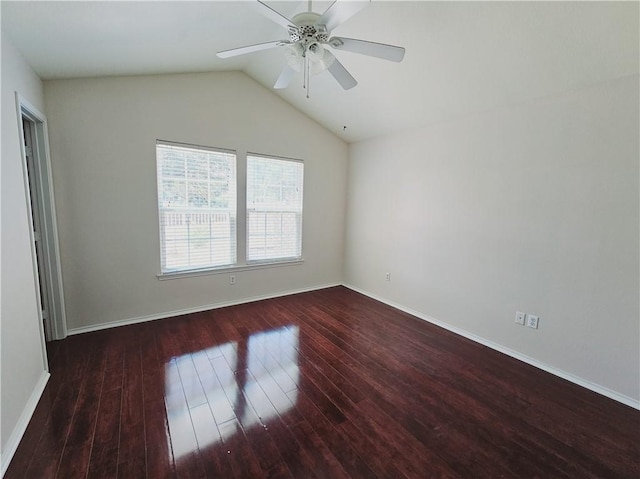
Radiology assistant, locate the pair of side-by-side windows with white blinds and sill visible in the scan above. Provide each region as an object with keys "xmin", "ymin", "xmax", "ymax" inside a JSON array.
[{"xmin": 156, "ymin": 140, "xmax": 304, "ymax": 279}]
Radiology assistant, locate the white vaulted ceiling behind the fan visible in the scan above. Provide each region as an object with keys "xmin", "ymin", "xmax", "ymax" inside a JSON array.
[{"xmin": 1, "ymin": 0, "xmax": 639, "ymax": 142}]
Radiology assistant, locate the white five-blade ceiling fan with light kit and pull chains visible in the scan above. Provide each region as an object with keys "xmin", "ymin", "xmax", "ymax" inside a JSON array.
[{"xmin": 217, "ymin": 0, "xmax": 404, "ymax": 98}]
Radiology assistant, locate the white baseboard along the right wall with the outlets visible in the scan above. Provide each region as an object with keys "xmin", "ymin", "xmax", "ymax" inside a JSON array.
[{"xmin": 343, "ymin": 283, "xmax": 640, "ymax": 410}]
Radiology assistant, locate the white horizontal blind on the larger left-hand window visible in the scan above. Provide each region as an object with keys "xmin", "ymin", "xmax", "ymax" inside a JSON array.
[{"xmin": 156, "ymin": 141, "xmax": 236, "ymax": 273}]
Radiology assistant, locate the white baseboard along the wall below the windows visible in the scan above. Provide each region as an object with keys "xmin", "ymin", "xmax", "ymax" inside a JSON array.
[{"xmin": 67, "ymin": 283, "xmax": 342, "ymax": 335}]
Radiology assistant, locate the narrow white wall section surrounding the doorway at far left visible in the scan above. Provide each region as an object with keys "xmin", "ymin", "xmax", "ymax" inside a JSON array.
[{"xmin": 0, "ymin": 35, "xmax": 46, "ymax": 469}]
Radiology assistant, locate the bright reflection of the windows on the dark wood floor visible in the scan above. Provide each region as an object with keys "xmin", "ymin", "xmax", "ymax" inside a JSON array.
[{"xmin": 165, "ymin": 325, "xmax": 300, "ymax": 461}]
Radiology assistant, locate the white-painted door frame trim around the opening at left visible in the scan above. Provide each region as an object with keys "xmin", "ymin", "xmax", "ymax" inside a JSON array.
[{"xmin": 16, "ymin": 92, "xmax": 67, "ymax": 341}]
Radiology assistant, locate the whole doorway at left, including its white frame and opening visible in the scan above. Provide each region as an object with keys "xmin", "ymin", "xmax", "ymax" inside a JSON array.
[{"xmin": 16, "ymin": 95, "xmax": 67, "ymax": 341}]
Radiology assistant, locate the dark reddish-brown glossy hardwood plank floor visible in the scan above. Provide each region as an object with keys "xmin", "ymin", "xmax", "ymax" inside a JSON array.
[{"xmin": 5, "ymin": 287, "xmax": 640, "ymax": 479}]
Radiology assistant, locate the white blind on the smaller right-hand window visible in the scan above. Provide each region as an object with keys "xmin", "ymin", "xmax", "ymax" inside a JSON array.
[{"xmin": 247, "ymin": 155, "xmax": 304, "ymax": 262}]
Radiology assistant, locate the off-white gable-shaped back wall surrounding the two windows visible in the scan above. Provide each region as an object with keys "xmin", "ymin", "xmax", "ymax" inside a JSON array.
[{"xmin": 45, "ymin": 72, "xmax": 348, "ymax": 329}]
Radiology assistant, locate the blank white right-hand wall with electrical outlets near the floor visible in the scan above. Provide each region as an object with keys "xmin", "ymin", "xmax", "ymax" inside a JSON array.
[{"xmin": 345, "ymin": 76, "xmax": 640, "ymax": 405}]
